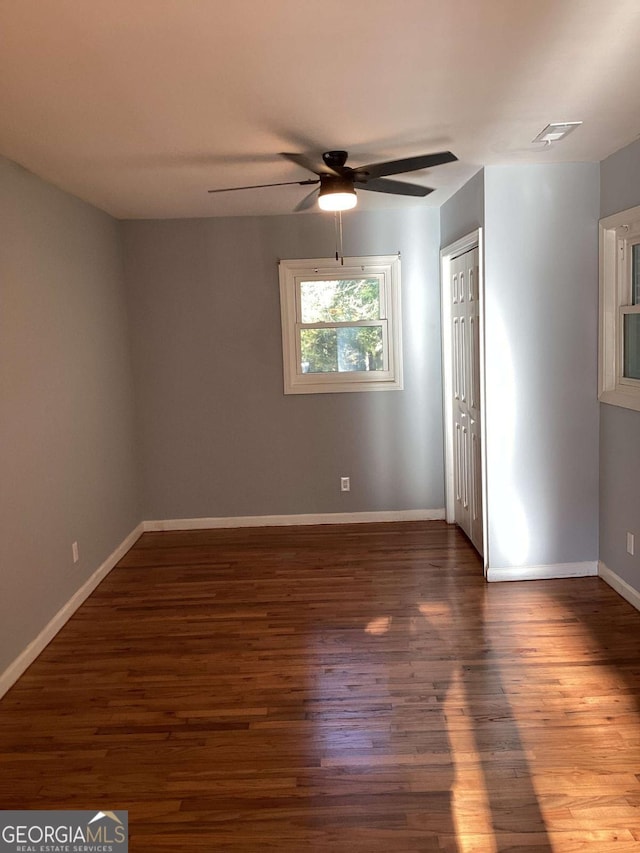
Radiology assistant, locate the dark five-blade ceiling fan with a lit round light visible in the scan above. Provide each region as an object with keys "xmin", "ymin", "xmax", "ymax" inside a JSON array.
[{"xmin": 209, "ymin": 151, "xmax": 458, "ymax": 210}]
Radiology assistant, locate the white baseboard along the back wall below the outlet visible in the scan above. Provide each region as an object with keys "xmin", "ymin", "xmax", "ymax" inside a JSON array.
[{"xmin": 143, "ymin": 507, "xmax": 444, "ymax": 532}]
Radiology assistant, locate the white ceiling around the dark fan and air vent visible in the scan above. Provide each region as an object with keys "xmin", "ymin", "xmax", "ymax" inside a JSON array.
[{"xmin": 0, "ymin": 0, "xmax": 640, "ymax": 218}]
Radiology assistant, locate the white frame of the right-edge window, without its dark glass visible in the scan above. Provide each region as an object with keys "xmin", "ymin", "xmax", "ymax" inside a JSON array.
[{"xmin": 598, "ymin": 207, "xmax": 640, "ymax": 411}]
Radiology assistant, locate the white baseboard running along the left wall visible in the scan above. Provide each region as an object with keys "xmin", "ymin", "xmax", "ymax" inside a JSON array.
[{"xmin": 0, "ymin": 524, "xmax": 144, "ymax": 699}]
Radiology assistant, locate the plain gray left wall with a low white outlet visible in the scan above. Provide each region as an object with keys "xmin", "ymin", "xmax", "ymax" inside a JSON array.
[{"xmin": 0, "ymin": 159, "xmax": 140, "ymax": 672}]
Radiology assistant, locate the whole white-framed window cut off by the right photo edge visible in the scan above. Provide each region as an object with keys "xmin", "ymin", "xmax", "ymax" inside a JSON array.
[{"xmin": 598, "ymin": 207, "xmax": 640, "ymax": 411}]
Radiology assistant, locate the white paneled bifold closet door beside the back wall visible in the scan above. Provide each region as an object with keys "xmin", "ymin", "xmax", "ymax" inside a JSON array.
[{"xmin": 450, "ymin": 248, "xmax": 483, "ymax": 554}]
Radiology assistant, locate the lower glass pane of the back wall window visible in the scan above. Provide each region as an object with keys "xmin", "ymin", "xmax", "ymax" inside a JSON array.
[{"xmin": 300, "ymin": 326, "xmax": 384, "ymax": 373}]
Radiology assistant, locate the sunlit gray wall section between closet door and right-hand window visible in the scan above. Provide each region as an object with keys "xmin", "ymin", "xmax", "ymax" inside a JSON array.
[{"xmin": 485, "ymin": 163, "xmax": 599, "ymax": 568}]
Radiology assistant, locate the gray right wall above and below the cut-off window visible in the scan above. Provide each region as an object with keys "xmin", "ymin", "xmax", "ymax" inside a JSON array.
[{"xmin": 600, "ymin": 142, "xmax": 640, "ymax": 591}]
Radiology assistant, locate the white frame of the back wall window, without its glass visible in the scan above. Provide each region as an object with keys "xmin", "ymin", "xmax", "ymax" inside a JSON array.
[{"xmin": 279, "ymin": 255, "xmax": 403, "ymax": 394}]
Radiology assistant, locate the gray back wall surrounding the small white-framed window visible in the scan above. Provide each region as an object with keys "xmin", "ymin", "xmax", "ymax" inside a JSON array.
[{"xmin": 124, "ymin": 209, "xmax": 444, "ymax": 519}]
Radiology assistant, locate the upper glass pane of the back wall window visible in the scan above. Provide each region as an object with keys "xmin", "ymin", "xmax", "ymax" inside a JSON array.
[{"xmin": 300, "ymin": 278, "xmax": 380, "ymax": 323}]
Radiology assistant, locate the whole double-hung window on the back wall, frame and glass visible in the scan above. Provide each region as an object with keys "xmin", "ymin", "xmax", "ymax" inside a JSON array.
[{"xmin": 279, "ymin": 255, "xmax": 402, "ymax": 394}]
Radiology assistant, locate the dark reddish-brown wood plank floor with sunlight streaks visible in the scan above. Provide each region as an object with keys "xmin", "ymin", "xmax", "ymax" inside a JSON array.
[{"xmin": 0, "ymin": 522, "xmax": 640, "ymax": 853}]
